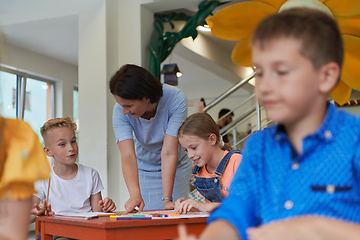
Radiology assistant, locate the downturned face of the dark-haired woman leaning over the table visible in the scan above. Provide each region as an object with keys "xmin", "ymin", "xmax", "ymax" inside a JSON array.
[{"xmin": 114, "ymin": 95, "xmax": 150, "ymax": 118}]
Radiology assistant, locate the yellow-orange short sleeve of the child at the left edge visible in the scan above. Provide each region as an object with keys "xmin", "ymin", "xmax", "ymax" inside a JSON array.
[{"xmin": 0, "ymin": 118, "xmax": 50, "ymax": 200}]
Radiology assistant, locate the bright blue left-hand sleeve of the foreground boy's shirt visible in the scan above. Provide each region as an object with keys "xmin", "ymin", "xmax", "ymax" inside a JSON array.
[{"xmin": 208, "ymin": 134, "xmax": 259, "ymax": 240}]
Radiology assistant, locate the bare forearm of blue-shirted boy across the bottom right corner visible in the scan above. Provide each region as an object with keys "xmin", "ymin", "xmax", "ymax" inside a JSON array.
[{"xmin": 247, "ymin": 216, "xmax": 360, "ymax": 240}]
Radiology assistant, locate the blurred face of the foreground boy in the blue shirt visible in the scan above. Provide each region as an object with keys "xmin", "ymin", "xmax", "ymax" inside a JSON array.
[{"xmin": 252, "ymin": 37, "xmax": 323, "ymax": 124}]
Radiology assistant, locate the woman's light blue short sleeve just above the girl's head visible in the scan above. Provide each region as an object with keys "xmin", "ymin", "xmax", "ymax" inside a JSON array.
[{"xmin": 165, "ymin": 90, "xmax": 188, "ymax": 137}]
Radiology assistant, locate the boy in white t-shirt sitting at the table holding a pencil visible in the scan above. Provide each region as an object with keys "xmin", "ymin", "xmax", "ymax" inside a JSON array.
[{"xmin": 32, "ymin": 117, "xmax": 116, "ymax": 222}]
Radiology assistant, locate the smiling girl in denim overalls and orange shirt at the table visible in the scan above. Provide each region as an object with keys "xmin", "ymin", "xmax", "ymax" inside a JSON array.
[{"xmin": 175, "ymin": 113, "xmax": 242, "ymax": 213}]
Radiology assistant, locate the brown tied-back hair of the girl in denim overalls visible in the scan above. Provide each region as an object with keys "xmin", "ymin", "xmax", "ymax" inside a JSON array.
[{"xmin": 178, "ymin": 113, "xmax": 232, "ymax": 151}]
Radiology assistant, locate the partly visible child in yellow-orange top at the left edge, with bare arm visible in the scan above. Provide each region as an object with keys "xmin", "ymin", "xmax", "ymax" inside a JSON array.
[{"xmin": 0, "ymin": 116, "xmax": 50, "ymax": 240}]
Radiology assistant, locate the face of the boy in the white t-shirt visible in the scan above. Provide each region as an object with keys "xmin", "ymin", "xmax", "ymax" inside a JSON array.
[{"xmin": 44, "ymin": 127, "xmax": 78, "ymax": 164}]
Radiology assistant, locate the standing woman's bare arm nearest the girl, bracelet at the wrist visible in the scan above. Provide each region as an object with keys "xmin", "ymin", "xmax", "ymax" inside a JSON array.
[{"xmin": 161, "ymin": 134, "xmax": 179, "ymax": 209}]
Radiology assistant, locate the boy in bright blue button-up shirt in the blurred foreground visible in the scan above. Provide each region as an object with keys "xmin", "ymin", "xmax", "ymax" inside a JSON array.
[{"xmin": 191, "ymin": 8, "xmax": 360, "ymax": 240}]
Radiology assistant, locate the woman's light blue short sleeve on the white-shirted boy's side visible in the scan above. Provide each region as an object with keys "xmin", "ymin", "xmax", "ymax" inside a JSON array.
[{"xmin": 113, "ymin": 103, "xmax": 133, "ymax": 143}]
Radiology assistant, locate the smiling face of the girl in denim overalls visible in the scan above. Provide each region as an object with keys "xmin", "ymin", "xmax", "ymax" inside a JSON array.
[{"xmin": 179, "ymin": 134, "xmax": 216, "ymax": 167}]
